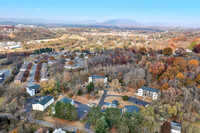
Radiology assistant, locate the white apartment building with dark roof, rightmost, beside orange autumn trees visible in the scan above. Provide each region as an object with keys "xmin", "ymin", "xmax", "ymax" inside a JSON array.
[{"xmin": 137, "ymin": 86, "xmax": 160, "ymax": 100}]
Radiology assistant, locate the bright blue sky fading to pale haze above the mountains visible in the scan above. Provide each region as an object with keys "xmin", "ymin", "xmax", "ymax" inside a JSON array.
[{"xmin": 0, "ymin": 0, "xmax": 200, "ymax": 24}]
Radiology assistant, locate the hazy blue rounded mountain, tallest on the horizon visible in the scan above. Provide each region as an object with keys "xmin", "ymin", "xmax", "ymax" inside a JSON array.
[{"xmin": 101, "ymin": 19, "xmax": 144, "ymax": 27}]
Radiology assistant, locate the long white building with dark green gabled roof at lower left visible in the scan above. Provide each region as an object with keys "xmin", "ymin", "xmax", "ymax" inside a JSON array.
[{"xmin": 32, "ymin": 95, "xmax": 54, "ymax": 111}]
